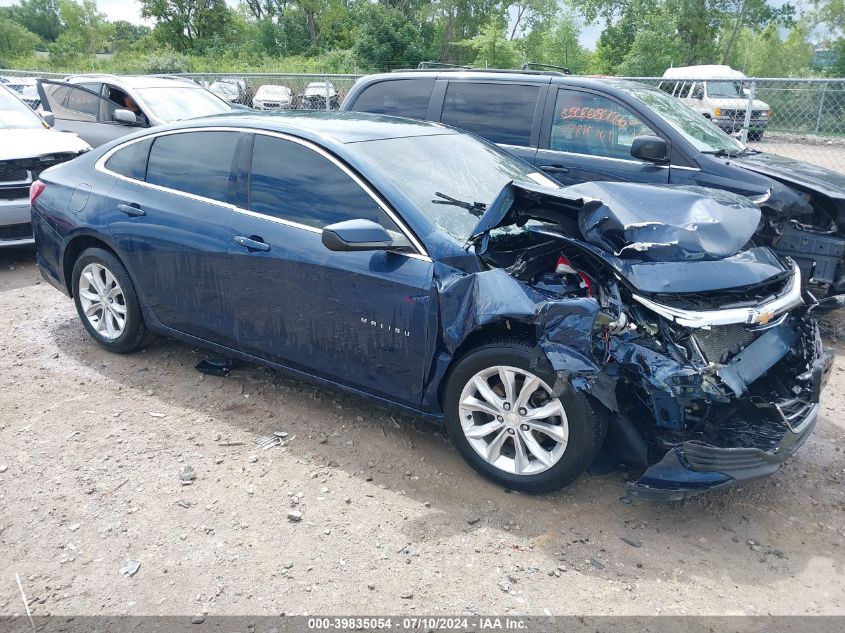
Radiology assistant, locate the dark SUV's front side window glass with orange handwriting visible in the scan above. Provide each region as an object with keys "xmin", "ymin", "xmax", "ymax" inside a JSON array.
[{"xmin": 549, "ymin": 88, "xmax": 655, "ymax": 160}]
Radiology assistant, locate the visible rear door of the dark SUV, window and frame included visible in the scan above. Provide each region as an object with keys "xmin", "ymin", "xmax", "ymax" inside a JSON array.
[{"xmin": 434, "ymin": 79, "xmax": 550, "ymax": 163}]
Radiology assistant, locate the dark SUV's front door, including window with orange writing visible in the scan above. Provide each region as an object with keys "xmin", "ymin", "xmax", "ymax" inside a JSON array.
[{"xmin": 534, "ymin": 87, "xmax": 669, "ymax": 185}]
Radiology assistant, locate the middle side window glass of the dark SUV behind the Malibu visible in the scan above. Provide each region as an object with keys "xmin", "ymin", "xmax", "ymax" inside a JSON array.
[{"xmin": 440, "ymin": 82, "xmax": 540, "ymax": 146}]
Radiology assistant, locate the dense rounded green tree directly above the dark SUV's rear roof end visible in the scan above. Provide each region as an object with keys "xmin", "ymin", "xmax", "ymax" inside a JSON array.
[{"xmin": 352, "ymin": 4, "xmax": 423, "ymax": 70}]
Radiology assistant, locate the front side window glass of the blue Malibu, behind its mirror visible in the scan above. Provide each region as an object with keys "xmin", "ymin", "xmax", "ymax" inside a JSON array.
[{"xmin": 249, "ymin": 134, "xmax": 398, "ymax": 231}]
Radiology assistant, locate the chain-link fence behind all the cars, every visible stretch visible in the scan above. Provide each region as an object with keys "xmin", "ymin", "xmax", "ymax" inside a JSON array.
[{"xmin": 0, "ymin": 70, "xmax": 845, "ymax": 173}]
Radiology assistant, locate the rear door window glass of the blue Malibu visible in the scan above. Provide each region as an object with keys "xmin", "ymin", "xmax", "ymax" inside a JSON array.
[{"xmin": 146, "ymin": 132, "xmax": 238, "ymax": 202}]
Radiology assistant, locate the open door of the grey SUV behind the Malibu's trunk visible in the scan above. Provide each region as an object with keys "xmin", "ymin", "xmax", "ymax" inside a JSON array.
[{"xmin": 38, "ymin": 79, "xmax": 136, "ymax": 147}]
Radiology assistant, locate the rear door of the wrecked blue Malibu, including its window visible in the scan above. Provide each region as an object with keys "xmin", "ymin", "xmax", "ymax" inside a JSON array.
[{"xmin": 102, "ymin": 131, "xmax": 242, "ymax": 346}]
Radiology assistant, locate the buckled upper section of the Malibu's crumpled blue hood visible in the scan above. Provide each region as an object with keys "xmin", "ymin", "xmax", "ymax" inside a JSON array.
[{"xmin": 567, "ymin": 182, "xmax": 760, "ymax": 262}]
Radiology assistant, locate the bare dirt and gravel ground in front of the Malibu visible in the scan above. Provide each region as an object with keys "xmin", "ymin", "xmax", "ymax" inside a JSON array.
[{"xmin": 0, "ymin": 248, "xmax": 845, "ymax": 615}]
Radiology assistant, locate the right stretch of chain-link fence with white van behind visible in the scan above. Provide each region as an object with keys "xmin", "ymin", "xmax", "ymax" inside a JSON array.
[{"xmin": 626, "ymin": 77, "xmax": 845, "ymax": 173}]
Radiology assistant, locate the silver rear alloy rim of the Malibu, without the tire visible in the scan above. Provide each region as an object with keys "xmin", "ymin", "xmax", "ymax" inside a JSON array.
[{"xmin": 79, "ymin": 263, "xmax": 126, "ymax": 341}]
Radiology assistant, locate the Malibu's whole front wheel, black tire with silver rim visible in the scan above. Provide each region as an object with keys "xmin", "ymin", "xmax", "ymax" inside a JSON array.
[{"xmin": 444, "ymin": 338, "xmax": 607, "ymax": 494}]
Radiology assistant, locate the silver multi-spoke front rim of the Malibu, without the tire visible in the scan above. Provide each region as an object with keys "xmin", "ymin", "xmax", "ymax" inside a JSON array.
[{"xmin": 458, "ymin": 366, "xmax": 569, "ymax": 475}]
